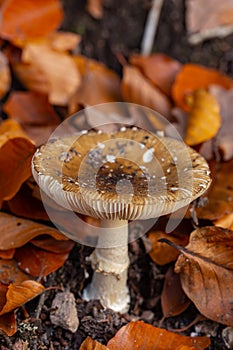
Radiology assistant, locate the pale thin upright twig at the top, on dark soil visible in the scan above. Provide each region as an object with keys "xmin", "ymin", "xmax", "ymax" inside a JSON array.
[{"xmin": 141, "ymin": 0, "xmax": 164, "ymax": 55}]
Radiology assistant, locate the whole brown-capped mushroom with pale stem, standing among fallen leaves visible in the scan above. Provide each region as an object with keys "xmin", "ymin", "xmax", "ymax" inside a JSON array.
[{"xmin": 32, "ymin": 127, "xmax": 211, "ymax": 313}]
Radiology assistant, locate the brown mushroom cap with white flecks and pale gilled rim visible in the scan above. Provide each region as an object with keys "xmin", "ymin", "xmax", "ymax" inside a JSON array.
[{"xmin": 32, "ymin": 127, "xmax": 211, "ymax": 220}]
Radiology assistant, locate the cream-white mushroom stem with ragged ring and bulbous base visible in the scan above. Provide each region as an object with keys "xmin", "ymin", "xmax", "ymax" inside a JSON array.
[{"xmin": 83, "ymin": 220, "xmax": 130, "ymax": 313}]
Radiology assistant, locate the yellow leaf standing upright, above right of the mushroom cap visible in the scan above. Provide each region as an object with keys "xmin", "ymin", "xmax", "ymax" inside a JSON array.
[{"xmin": 184, "ymin": 89, "xmax": 221, "ymax": 146}]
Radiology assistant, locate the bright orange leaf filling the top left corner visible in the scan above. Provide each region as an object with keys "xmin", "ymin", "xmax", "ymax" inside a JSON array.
[{"xmin": 0, "ymin": 0, "xmax": 63, "ymax": 41}]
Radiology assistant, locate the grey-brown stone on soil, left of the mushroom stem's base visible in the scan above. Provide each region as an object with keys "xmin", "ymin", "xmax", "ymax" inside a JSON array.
[{"xmin": 50, "ymin": 292, "xmax": 79, "ymax": 333}]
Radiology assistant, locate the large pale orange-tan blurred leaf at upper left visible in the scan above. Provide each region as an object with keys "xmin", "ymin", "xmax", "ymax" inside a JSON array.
[{"xmin": 20, "ymin": 43, "xmax": 81, "ymax": 106}]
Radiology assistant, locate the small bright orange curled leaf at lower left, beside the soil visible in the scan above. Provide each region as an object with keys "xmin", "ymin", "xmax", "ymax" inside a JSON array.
[{"xmin": 0, "ymin": 280, "xmax": 45, "ymax": 315}]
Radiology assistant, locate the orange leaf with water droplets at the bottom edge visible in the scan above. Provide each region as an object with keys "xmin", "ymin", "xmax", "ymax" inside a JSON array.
[{"xmin": 107, "ymin": 321, "xmax": 210, "ymax": 350}]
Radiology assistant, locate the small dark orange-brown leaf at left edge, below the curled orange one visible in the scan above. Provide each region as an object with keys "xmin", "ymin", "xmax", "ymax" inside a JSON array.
[{"xmin": 0, "ymin": 259, "xmax": 30, "ymax": 285}]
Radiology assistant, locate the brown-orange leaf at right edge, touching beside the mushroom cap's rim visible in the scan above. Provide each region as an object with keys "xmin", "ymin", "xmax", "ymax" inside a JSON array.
[{"xmin": 196, "ymin": 159, "xmax": 233, "ymax": 220}]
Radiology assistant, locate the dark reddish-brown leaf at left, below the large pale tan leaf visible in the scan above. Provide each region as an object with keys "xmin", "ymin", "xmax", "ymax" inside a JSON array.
[{"xmin": 3, "ymin": 91, "xmax": 60, "ymax": 126}]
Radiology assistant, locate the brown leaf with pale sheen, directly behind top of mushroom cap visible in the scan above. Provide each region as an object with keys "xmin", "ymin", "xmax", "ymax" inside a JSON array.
[{"xmin": 122, "ymin": 66, "xmax": 171, "ymax": 119}]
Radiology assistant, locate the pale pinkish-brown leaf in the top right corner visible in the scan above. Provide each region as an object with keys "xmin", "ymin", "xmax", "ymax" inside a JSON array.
[{"xmin": 186, "ymin": 0, "xmax": 233, "ymax": 44}]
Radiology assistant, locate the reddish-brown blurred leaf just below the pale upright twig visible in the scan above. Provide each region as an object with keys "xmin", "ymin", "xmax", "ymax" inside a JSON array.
[{"xmin": 130, "ymin": 53, "xmax": 182, "ymax": 96}]
